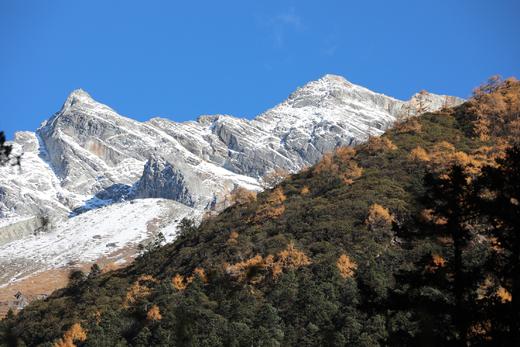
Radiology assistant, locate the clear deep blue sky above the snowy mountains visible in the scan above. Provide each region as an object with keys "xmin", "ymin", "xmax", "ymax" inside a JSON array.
[{"xmin": 0, "ymin": 0, "xmax": 520, "ymax": 137}]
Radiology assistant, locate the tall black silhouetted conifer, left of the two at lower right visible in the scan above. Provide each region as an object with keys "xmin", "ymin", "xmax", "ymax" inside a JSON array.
[{"xmin": 394, "ymin": 165, "xmax": 481, "ymax": 346}]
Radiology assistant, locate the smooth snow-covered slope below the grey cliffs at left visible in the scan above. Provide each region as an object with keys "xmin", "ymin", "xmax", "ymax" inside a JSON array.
[{"xmin": 0, "ymin": 199, "xmax": 196, "ymax": 287}]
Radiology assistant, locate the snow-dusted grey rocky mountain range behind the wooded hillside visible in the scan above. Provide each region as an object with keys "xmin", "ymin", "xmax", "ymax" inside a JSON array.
[{"xmin": 0, "ymin": 75, "xmax": 463, "ymax": 285}]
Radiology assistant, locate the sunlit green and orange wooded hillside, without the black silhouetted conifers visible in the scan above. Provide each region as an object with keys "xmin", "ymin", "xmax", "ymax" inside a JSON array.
[{"xmin": 0, "ymin": 80, "xmax": 520, "ymax": 346}]
